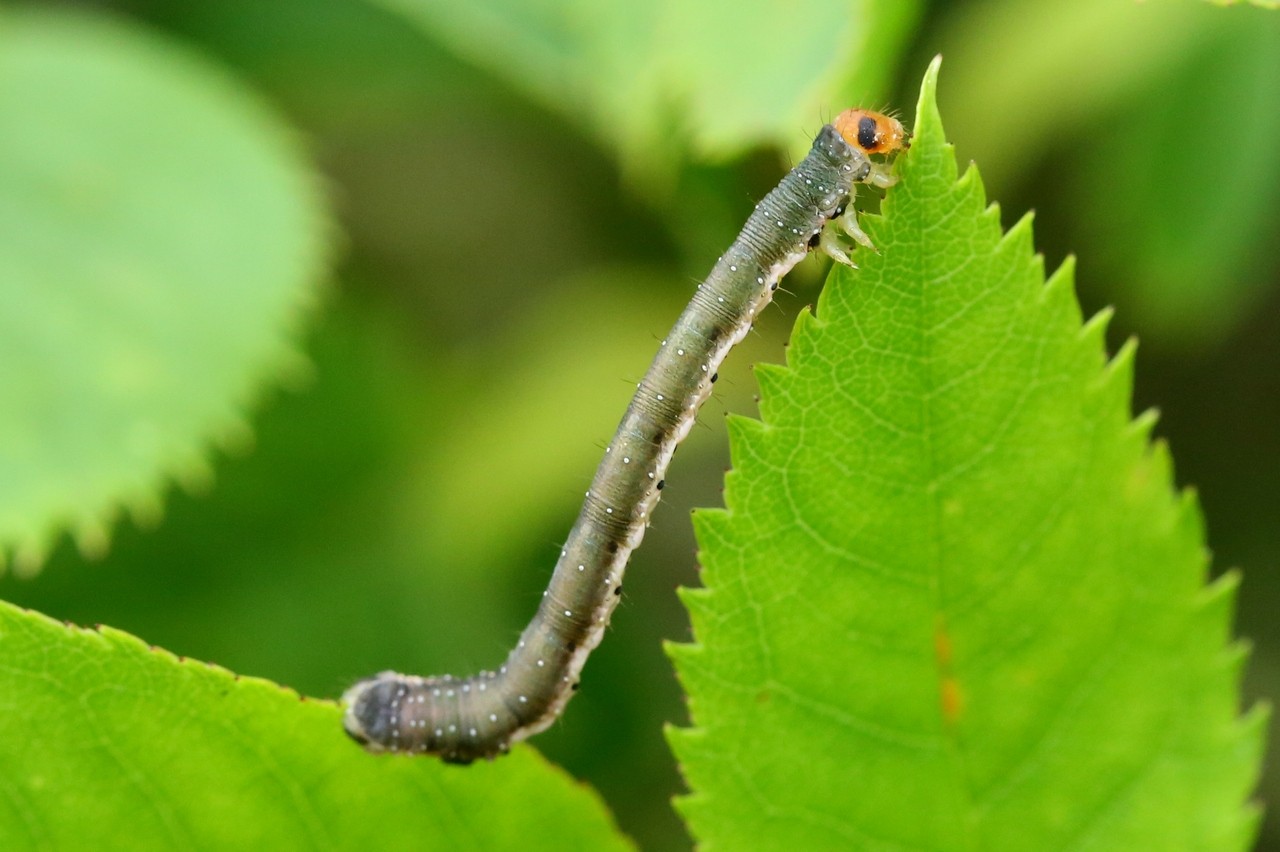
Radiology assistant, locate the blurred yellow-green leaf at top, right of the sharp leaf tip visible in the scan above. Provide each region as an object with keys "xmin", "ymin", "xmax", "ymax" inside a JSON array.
[{"xmin": 945, "ymin": 0, "xmax": 1208, "ymax": 184}]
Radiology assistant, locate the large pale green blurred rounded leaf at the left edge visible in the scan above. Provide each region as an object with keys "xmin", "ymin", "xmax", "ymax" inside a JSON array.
[{"xmin": 0, "ymin": 10, "xmax": 330, "ymax": 569}]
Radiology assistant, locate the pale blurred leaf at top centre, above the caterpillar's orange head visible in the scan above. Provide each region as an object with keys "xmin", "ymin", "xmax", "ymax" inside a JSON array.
[{"xmin": 379, "ymin": 0, "xmax": 919, "ymax": 169}]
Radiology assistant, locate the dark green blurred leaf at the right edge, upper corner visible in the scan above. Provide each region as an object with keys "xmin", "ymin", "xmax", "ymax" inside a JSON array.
[{"xmin": 1071, "ymin": 9, "xmax": 1280, "ymax": 342}]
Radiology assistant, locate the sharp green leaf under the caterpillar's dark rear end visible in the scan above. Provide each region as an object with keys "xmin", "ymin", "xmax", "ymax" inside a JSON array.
[{"xmin": 0, "ymin": 604, "xmax": 627, "ymax": 849}]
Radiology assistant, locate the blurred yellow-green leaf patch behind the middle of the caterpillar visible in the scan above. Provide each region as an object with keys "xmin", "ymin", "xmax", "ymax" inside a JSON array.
[{"xmin": 401, "ymin": 269, "xmax": 681, "ymax": 573}]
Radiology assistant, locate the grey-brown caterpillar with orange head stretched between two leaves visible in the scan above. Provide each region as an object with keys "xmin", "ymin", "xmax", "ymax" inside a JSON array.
[{"xmin": 343, "ymin": 110, "xmax": 909, "ymax": 764}]
